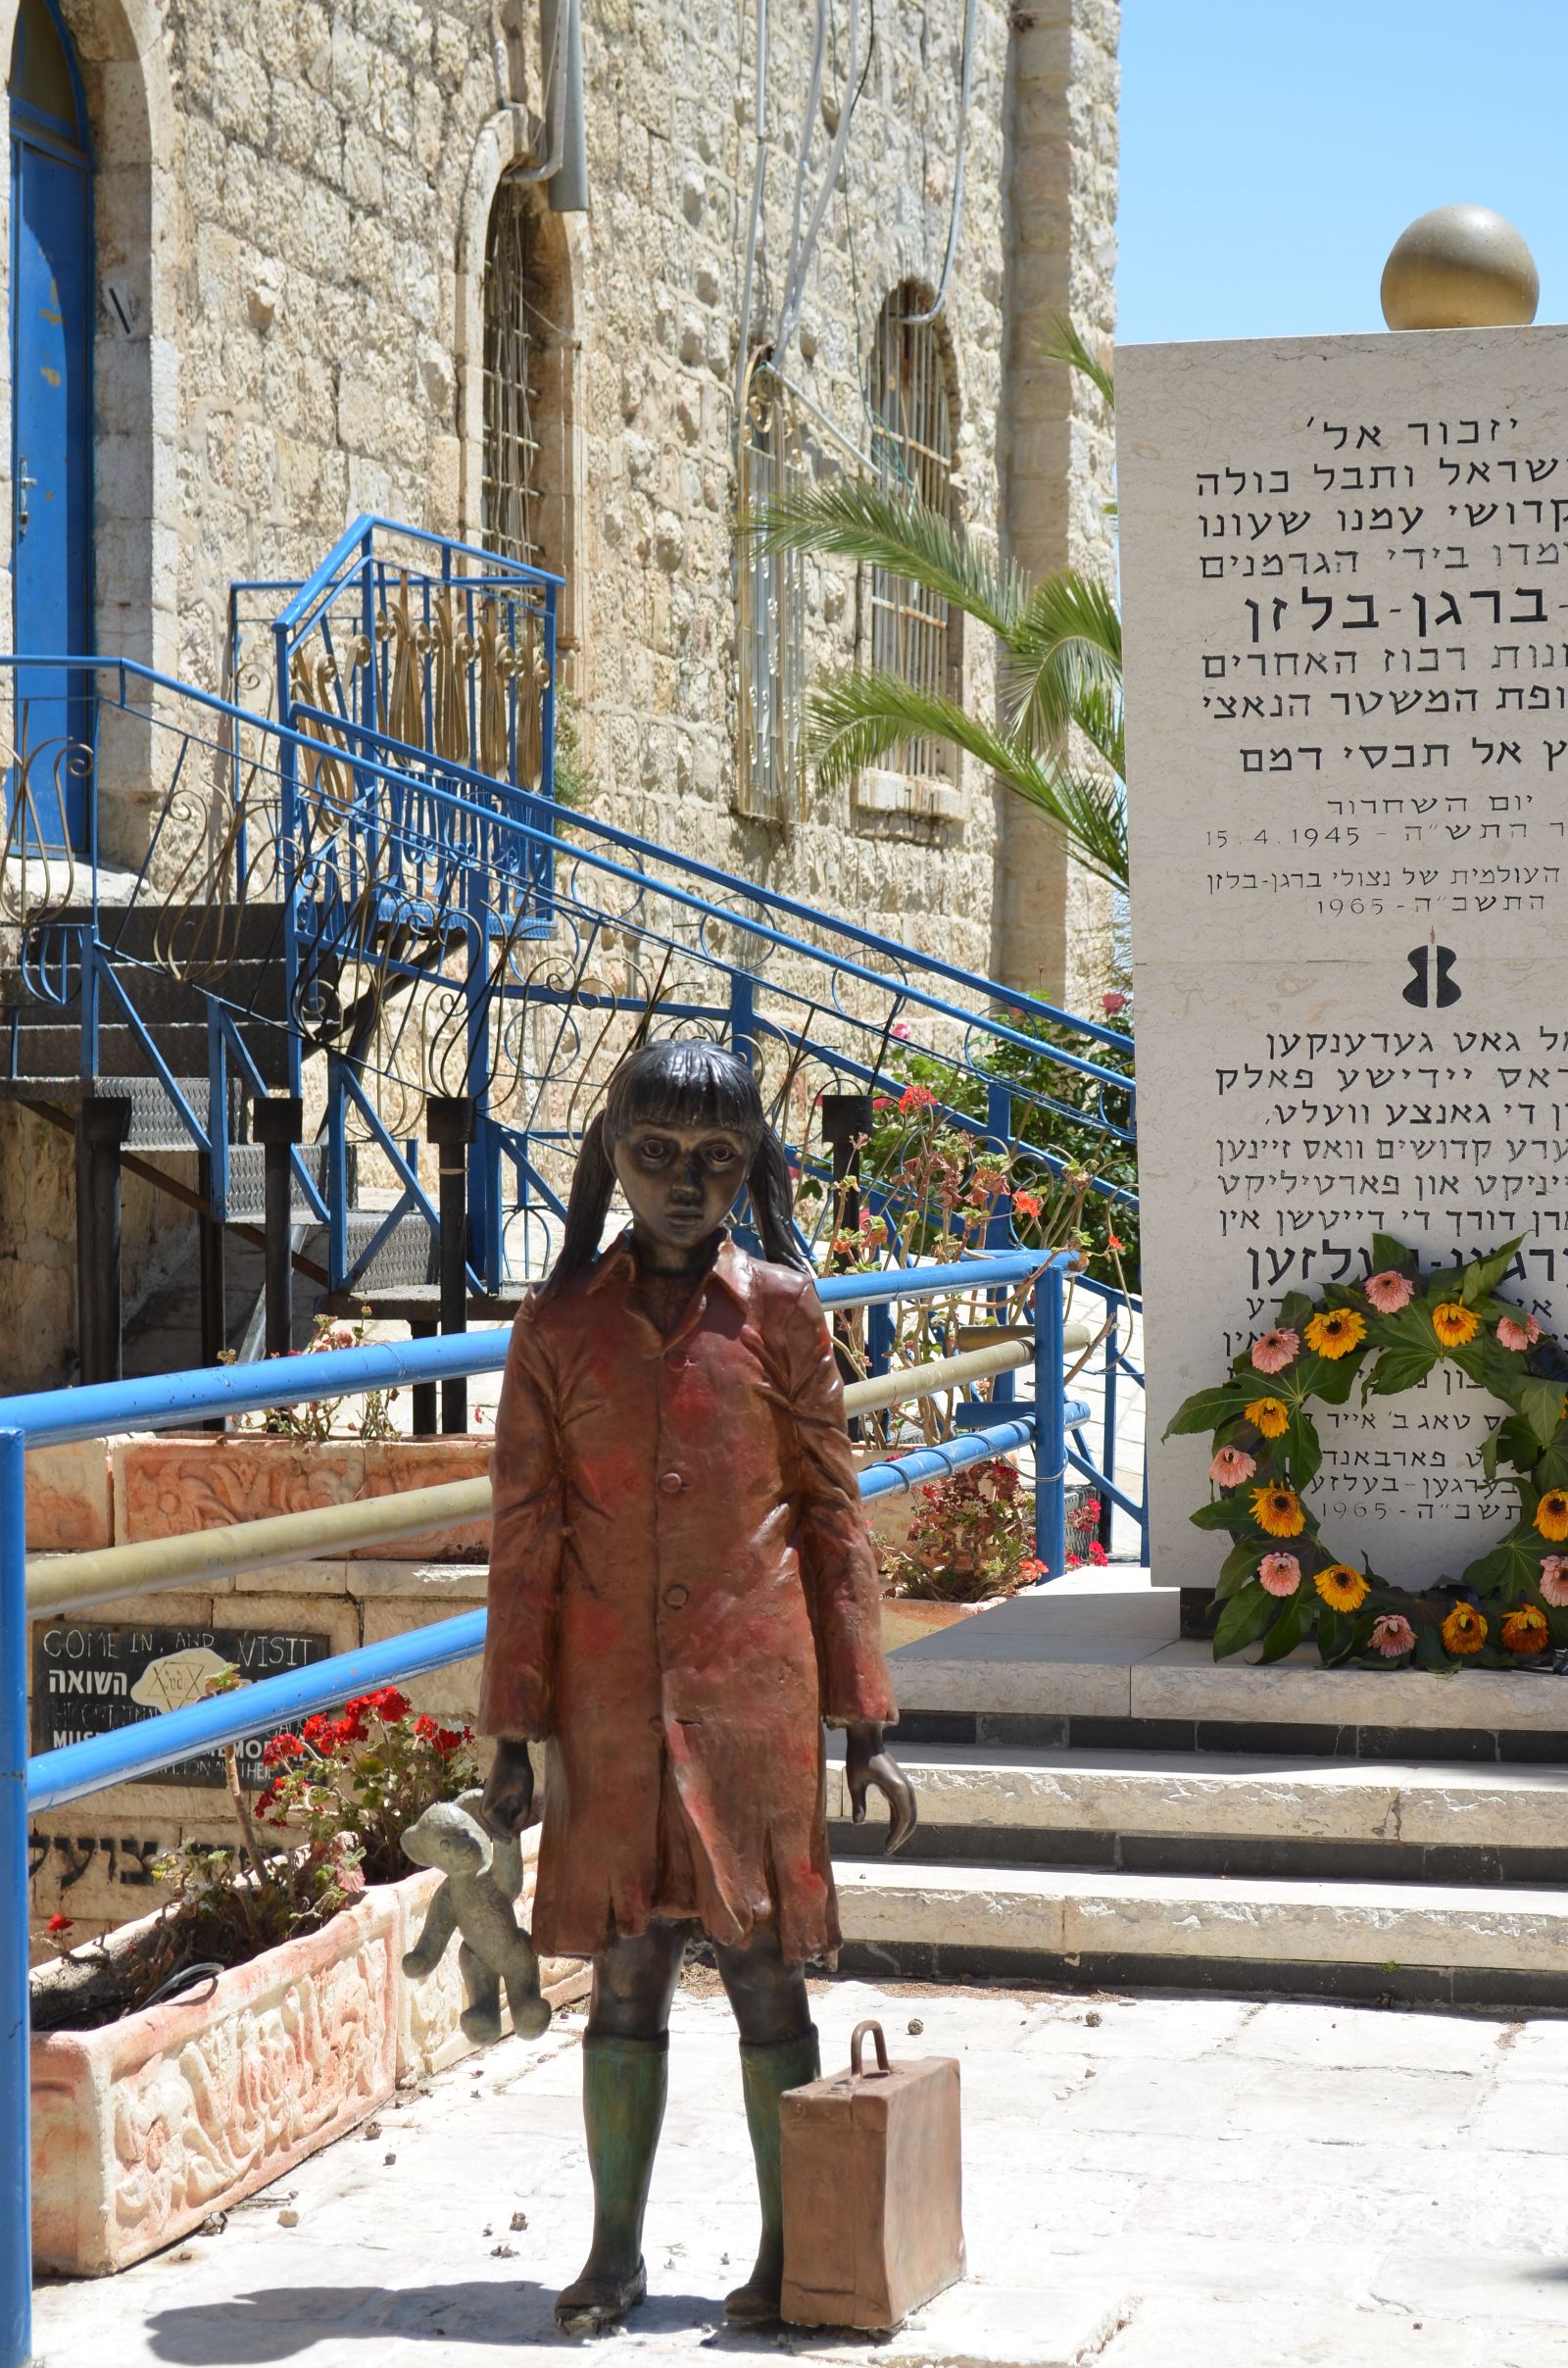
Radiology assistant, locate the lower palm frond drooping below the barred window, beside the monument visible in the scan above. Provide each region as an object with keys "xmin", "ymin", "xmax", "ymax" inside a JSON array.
[{"xmin": 806, "ymin": 667, "xmax": 1127, "ymax": 888}]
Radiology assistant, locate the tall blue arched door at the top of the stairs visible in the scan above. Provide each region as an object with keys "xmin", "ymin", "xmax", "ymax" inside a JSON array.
[{"xmin": 7, "ymin": 0, "xmax": 92, "ymax": 848}]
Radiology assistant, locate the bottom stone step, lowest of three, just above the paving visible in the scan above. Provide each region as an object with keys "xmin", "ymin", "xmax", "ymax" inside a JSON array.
[{"xmin": 836, "ymin": 1859, "xmax": 1568, "ymax": 2013}]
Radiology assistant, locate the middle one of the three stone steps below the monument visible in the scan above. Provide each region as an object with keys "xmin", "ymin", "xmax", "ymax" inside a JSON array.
[{"xmin": 827, "ymin": 1734, "xmax": 1568, "ymax": 1888}]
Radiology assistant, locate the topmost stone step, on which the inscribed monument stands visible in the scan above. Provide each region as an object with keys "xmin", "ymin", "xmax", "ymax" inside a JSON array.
[{"xmin": 891, "ymin": 1570, "xmax": 1568, "ymax": 1764}]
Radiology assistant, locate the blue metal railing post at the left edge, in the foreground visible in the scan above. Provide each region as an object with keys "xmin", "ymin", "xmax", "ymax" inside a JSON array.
[{"xmin": 0, "ymin": 1430, "xmax": 33, "ymax": 2368}]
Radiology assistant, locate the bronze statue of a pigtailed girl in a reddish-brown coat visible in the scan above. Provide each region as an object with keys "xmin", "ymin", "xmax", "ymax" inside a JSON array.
[{"xmin": 481, "ymin": 1040, "xmax": 914, "ymax": 2333}]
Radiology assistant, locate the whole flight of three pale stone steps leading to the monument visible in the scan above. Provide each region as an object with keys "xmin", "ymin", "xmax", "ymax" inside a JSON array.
[{"xmin": 829, "ymin": 1572, "xmax": 1568, "ymax": 2010}]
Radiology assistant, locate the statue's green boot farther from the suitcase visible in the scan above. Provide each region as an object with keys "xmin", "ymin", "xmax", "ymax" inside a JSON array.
[{"xmin": 555, "ymin": 2034, "xmax": 670, "ymax": 2335}]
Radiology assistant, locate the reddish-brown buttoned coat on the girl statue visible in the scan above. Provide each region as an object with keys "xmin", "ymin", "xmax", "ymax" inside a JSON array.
[{"xmin": 481, "ymin": 1236, "xmax": 896, "ymax": 1963}]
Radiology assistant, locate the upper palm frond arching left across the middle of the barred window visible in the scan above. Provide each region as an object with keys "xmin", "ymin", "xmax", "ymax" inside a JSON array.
[{"xmin": 741, "ymin": 476, "xmax": 1026, "ymax": 637}]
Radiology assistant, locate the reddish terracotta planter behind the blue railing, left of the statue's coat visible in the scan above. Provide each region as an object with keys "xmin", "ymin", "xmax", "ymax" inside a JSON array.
[{"xmin": 114, "ymin": 1433, "xmax": 490, "ymax": 1563}]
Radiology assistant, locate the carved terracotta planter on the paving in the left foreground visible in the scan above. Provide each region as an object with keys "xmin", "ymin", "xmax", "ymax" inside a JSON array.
[{"xmin": 33, "ymin": 1868, "xmax": 590, "ymax": 2278}]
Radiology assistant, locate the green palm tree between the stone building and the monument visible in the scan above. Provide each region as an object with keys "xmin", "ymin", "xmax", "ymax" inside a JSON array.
[{"xmin": 746, "ymin": 322, "xmax": 1127, "ymax": 890}]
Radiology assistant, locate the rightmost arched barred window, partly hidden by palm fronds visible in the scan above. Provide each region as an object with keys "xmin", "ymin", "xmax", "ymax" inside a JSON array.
[{"xmin": 867, "ymin": 279, "xmax": 961, "ymax": 781}]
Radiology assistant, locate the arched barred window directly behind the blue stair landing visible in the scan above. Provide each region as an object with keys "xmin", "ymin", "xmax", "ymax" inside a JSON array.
[{"xmin": 481, "ymin": 177, "xmax": 550, "ymax": 566}]
